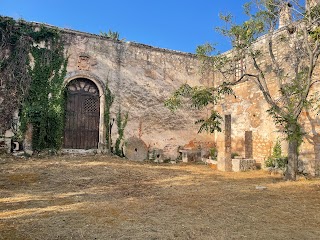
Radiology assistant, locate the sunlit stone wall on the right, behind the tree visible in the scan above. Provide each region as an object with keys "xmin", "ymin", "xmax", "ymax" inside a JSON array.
[{"xmin": 214, "ymin": 30, "xmax": 320, "ymax": 175}]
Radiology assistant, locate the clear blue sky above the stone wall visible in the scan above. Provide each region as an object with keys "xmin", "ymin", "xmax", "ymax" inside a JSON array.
[{"xmin": 0, "ymin": 0, "xmax": 247, "ymax": 53}]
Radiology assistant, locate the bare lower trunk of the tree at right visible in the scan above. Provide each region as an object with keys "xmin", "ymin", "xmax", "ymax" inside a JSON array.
[{"xmin": 285, "ymin": 139, "xmax": 299, "ymax": 181}]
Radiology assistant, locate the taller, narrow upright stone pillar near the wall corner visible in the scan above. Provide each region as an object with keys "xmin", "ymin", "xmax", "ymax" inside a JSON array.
[{"xmin": 218, "ymin": 115, "xmax": 232, "ymax": 172}]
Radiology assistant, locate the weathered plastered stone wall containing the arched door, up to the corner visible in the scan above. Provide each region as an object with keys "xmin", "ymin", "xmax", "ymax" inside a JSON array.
[{"xmin": 63, "ymin": 31, "xmax": 214, "ymax": 159}]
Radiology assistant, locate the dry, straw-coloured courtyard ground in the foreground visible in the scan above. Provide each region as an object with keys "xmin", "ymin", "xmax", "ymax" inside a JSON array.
[{"xmin": 0, "ymin": 156, "xmax": 320, "ymax": 240}]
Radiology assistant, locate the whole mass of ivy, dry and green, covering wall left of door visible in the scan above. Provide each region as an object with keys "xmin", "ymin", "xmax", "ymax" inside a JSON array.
[{"xmin": 0, "ymin": 17, "xmax": 67, "ymax": 151}]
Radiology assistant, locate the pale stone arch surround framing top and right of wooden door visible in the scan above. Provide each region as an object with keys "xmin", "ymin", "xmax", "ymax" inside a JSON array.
[{"xmin": 64, "ymin": 71, "xmax": 106, "ymax": 153}]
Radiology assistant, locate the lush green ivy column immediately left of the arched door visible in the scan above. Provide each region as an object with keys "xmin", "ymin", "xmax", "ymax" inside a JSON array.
[{"xmin": 21, "ymin": 26, "xmax": 67, "ymax": 151}]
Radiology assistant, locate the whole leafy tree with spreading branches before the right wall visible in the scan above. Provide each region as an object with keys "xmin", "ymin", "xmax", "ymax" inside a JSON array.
[{"xmin": 166, "ymin": 0, "xmax": 320, "ymax": 180}]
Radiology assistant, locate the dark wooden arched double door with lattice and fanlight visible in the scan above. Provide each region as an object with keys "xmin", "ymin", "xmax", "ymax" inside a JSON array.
[{"xmin": 64, "ymin": 78, "xmax": 100, "ymax": 149}]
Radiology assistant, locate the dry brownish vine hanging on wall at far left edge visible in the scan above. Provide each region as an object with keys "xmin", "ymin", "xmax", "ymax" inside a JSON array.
[{"xmin": 0, "ymin": 17, "xmax": 32, "ymax": 133}]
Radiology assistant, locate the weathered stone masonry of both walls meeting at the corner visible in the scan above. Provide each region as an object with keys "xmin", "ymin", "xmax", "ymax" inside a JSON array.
[{"xmin": 0, "ymin": 14, "xmax": 320, "ymax": 174}]
